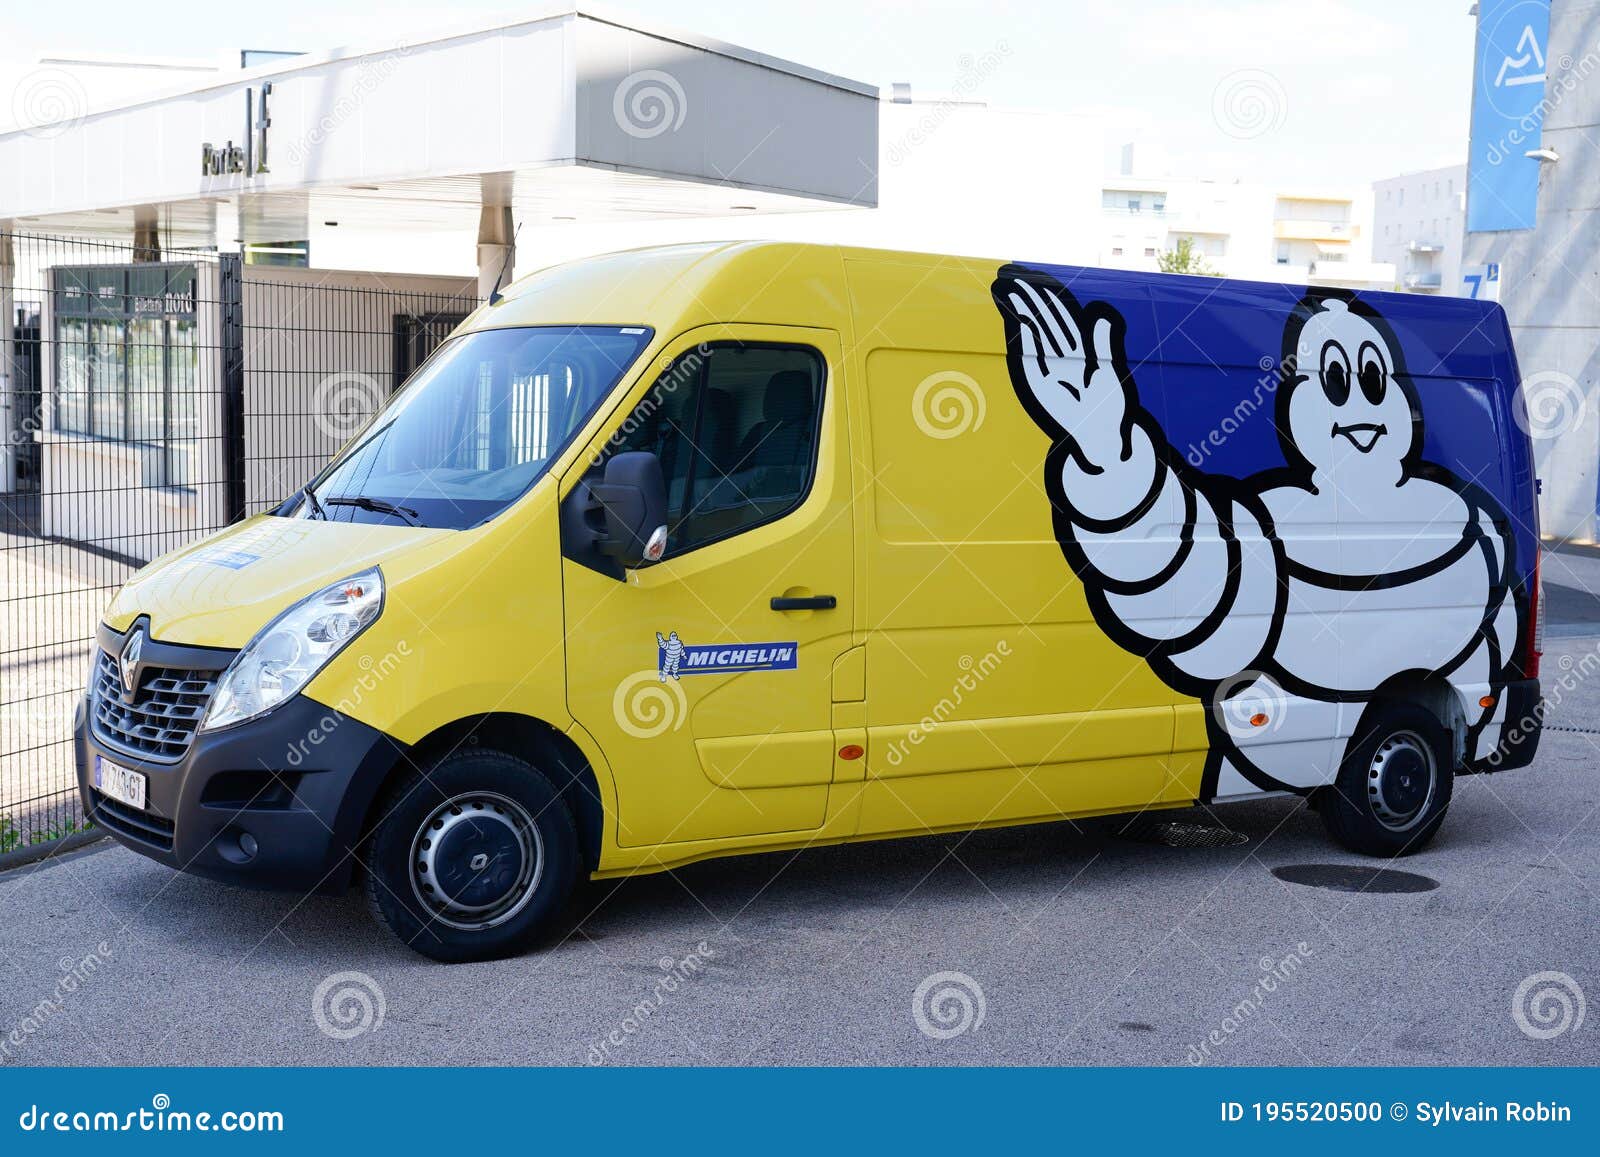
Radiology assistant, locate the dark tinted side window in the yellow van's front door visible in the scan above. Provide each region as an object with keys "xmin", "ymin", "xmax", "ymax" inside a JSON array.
[{"xmin": 604, "ymin": 342, "xmax": 824, "ymax": 555}]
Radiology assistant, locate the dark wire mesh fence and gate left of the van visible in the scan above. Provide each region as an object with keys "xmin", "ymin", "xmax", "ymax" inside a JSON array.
[{"xmin": 0, "ymin": 232, "xmax": 478, "ymax": 863}]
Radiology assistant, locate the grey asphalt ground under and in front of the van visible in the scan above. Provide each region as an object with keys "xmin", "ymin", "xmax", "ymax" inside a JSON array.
[{"xmin": 0, "ymin": 552, "xmax": 1600, "ymax": 1066}]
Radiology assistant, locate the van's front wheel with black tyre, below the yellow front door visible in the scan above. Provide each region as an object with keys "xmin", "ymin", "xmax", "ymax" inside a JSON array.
[{"xmin": 366, "ymin": 749, "xmax": 581, "ymax": 963}]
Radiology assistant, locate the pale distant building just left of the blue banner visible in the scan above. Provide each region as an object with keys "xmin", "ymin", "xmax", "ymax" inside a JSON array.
[{"xmin": 1373, "ymin": 165, "xmax": 1467, "ymax": 296}]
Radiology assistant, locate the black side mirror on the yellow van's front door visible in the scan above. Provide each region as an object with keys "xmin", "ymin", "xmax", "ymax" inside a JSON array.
[{"xmin": 562, "ymin": 450, "xmax": 667, "ymax": 578}]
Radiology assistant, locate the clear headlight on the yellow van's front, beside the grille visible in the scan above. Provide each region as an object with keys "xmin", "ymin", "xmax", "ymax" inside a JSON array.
[{"xmin": 200, "ymin": 568, "xmax": 384, "ymax": 731}]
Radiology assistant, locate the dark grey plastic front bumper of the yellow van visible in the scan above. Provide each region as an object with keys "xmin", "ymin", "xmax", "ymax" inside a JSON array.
[{"xmin": 74, "ymin": 627, "xmax": 405, "ymax": 893}]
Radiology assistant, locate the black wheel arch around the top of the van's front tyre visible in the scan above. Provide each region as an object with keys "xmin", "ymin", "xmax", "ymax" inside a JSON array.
[{"xmin": 362, "ymin": 712, "xmax": 605, "ymax": 872}]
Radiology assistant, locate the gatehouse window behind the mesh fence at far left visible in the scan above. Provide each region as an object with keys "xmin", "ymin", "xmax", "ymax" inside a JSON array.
[{"xmin": 54, "ymin": 264, "xmax": 198, "ymax": 486}]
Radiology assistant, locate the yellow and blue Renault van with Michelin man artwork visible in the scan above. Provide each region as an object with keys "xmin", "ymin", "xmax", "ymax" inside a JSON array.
[{"xmin": 77, "ymin": 243, "xmax": 1541, "ymax": 960}]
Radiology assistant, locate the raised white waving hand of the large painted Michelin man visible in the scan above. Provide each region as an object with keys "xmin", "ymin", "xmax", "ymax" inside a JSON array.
[{"xmin": 994, "ymin": 275, "xmax": 1131, "ymax": 474}]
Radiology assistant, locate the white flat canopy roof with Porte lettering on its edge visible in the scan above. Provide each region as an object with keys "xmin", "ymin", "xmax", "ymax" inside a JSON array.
[{"xmin": 0, "ymin": 10, "xmax": 878, "ymax": 245}]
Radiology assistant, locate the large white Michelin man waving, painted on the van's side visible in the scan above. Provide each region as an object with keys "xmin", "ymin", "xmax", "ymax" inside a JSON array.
[{"xmin": 994, "ymin": 266, "xmax": 1520, "ymax": 799}]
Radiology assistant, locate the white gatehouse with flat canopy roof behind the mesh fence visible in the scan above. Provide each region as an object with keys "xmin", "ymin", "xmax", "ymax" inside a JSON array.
[{"xmin": 0, "ymin": 10, "xmax": 878, "ymax": 558}]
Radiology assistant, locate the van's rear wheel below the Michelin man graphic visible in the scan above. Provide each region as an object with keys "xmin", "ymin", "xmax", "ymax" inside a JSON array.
[{"xmin": 1320, "ymin": 703, "xmax": 1454, "ymax": 856}]
